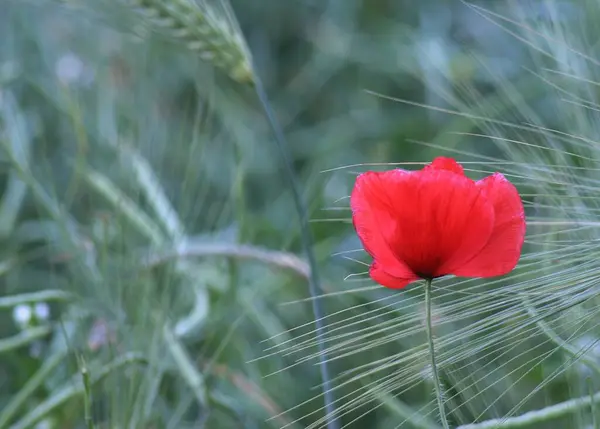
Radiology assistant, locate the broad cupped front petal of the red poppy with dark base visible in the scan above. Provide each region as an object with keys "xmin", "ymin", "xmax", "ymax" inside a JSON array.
[{"xmin": 351, "ymin": 168, "xmax": 494, "ymax": 279}]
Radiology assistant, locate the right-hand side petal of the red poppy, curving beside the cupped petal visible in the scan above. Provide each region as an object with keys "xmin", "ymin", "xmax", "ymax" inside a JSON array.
[{"xmin": 452, "ymin": 173, "xmax": 525, "ymax": 277}]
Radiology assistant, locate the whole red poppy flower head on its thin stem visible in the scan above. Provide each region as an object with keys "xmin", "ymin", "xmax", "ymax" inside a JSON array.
[{"xmin": 350, "ymin": 157, "xmax": 525, "ymax": 288}]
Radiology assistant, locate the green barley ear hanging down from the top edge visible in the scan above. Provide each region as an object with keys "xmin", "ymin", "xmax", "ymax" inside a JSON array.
[{"xmin": 126, "ymin": 0, "xmax": 255, "ymax": 84}]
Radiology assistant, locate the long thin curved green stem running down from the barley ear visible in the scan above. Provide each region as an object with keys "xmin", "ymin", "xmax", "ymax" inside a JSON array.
[{"xmin": 255, "ymin": 76, "xmax": 339, "ymax": 429}]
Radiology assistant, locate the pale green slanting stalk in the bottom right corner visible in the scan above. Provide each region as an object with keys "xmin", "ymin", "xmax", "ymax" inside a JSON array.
[{"xmin": 456, "ymin": 392, "xmax": 600, "ymax": 429}]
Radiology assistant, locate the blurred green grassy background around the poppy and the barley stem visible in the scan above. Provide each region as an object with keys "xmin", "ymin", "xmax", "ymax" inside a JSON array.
[{"xmin": 0, "ymin": 0, "xmax": 600, "ymax": 429}]
